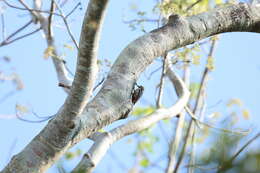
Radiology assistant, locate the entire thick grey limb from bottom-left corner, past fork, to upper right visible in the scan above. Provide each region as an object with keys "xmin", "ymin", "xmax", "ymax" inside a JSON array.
[{"xmin": 1, "ymin": 4, "xmax": 260, "ymax": 173}]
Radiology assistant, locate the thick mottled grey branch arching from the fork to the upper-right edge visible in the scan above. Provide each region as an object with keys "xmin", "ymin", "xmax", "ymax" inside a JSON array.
[{"xmin": 77, "ymin": 4, "xmax": 260, "ymax": 139}]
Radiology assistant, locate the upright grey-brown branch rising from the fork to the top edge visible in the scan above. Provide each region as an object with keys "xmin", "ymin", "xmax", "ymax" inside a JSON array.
[{"xmin": 62, "ymin": 0, "xmax": 108, "ymax": 119}]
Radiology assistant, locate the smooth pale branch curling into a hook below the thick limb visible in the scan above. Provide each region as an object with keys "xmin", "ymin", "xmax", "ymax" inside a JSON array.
[{"xmin": 74, "ymin": 71, "xmax": 190, "ymax": 173}]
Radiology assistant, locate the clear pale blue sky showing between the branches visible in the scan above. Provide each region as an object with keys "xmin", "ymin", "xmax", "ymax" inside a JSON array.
[{"xmin": 0, "ymin": 0, "xmax": 260, "ymax": 173}]
